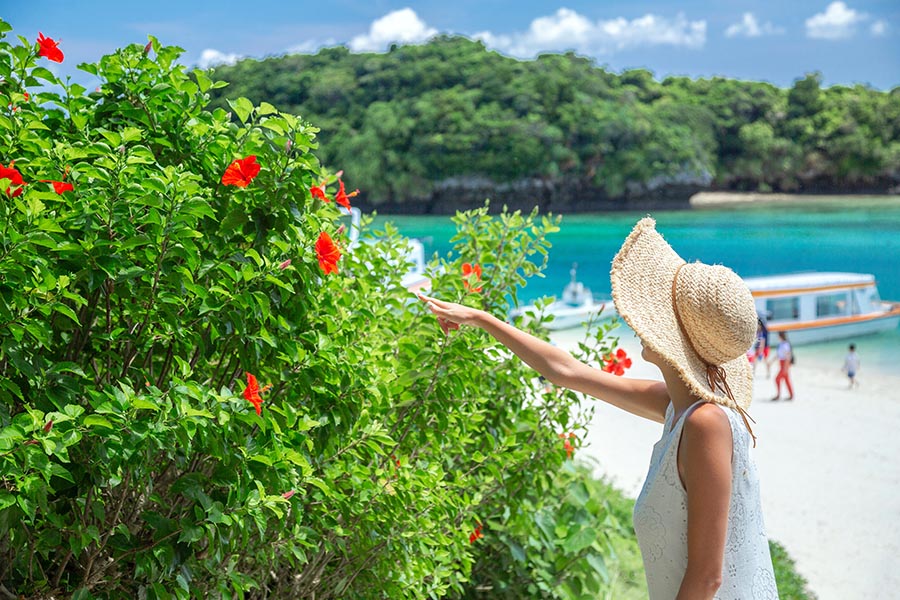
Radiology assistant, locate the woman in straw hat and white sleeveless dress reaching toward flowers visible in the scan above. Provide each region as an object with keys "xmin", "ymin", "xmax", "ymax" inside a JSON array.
[{"xmin": 419, "ymin": 217, "xmax": 778, "ymax": 600}]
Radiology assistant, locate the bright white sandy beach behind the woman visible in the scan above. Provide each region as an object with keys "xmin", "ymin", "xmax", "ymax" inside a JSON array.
[{"xmin": 554, "ymin": 332, "xmax": 900, "ymax": 600}]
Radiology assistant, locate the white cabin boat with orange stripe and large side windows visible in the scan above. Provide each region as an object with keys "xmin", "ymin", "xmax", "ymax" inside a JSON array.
[{"xmin": 744, "ymin": 272, "xmax": 900, "ymax": 344}]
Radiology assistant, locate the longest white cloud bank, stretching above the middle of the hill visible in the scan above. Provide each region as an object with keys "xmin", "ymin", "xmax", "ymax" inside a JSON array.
[{"xmin": 473, "ymin": 8, "xmax": 706, "ymax": 58}]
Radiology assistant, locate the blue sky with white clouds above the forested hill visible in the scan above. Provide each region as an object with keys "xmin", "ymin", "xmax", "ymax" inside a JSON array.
[{"xmin": 0, "ymin": 0, "xmax": 900, "ymax": 90}]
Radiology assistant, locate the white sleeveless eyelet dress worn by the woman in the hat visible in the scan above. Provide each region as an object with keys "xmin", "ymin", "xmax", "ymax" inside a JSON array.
[{"xmin": 634, "ymin": 402, "xmax": 778, "ymax": 600}]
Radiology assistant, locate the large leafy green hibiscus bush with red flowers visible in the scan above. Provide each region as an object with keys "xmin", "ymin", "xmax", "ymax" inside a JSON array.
[{"xmin": 0, "ymin": 21, "xmax": 622, "ymax": 600}]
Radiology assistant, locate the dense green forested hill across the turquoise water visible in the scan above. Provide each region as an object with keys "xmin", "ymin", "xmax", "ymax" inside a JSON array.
[{"xmin": 214, "ymin": 37, "xmax": 900, "ymax": 213}]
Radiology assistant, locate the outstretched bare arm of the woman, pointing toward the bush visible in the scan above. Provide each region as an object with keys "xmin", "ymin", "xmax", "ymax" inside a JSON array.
[{"xmin": 419, "ymin": 294, "xmax": 669, "ymax": 423}]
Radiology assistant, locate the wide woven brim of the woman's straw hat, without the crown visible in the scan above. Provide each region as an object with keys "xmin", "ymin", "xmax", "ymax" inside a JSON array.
[{"xmin": 610, "ymin": 217, "xmax": 753, "ymax": 410}]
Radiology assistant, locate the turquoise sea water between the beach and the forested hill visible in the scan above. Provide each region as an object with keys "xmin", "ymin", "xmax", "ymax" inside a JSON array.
[{"xmin": 376, "ymin": 197, "xmax": 900, "ymax": 376}]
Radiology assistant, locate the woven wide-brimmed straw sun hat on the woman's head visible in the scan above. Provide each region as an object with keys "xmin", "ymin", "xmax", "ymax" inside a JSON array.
[{"xmin": 610, "ymin": 217, "xmax": 757, "ymax": 418}]
